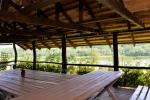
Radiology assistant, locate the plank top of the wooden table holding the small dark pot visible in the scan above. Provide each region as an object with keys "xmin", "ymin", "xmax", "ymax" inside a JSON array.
[{"xmin": 0, "ymin": 69, "xmax": 76, "ymax": 96}]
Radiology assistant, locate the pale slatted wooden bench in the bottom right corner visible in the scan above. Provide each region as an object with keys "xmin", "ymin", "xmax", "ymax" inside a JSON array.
[{"xmin": 130, "ymin": 85, "xmax": 150, "ymax": 100}]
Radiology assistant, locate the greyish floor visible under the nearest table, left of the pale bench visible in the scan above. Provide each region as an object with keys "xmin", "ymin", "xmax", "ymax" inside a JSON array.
[{"xmin": 98, "ymin": 87, "xmax": 134, "ymax": 100}]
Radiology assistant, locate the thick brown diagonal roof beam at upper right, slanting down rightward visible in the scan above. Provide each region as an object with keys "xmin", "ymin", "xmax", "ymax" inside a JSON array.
[{"xmin": 97, "ymin": 0, "xmax": 144, "ymax": 28}]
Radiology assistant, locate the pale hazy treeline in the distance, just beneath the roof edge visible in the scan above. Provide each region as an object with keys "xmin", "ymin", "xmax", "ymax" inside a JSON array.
[{"xmin": 0, "ymin": 44, "xmax": 150, "ymax": 61}]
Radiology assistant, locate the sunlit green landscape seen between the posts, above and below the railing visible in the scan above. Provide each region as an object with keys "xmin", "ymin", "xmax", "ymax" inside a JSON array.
[{"xmin": 0, "ymin": 44, "xmax": 150, "ymax": 87}]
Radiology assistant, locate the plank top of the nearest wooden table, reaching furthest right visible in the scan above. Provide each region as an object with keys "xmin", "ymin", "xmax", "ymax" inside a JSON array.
[{"xmin": 12, "ymin": 71, "xmax": 122, "ymax": 100}]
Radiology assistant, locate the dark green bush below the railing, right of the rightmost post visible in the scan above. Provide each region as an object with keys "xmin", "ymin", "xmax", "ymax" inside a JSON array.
[{"xmin": 119, "ymin": 69, "xmax": 150, "ymax": 87}]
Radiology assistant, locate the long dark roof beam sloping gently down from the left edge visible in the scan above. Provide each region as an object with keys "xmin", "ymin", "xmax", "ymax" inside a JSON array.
[{"xmin": 0, "ymin": 12, "xmax": 96, "ymax": 32}]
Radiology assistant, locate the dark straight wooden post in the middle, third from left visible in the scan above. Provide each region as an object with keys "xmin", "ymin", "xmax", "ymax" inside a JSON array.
[{"xmin": 62, "ymin": 33, "xmax": 67, "ymax": 73}]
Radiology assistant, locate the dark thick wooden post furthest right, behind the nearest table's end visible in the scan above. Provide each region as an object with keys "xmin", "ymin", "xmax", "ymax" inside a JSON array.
[{"xmin": 113, "ymin": 33, "xmax": 119, "ymax": 71}]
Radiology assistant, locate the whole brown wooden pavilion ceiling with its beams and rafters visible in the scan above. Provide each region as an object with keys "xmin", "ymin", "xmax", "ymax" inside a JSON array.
[{"xmin": 0, "ymin": 0, "xmax": 150, "ymax": 49}]
